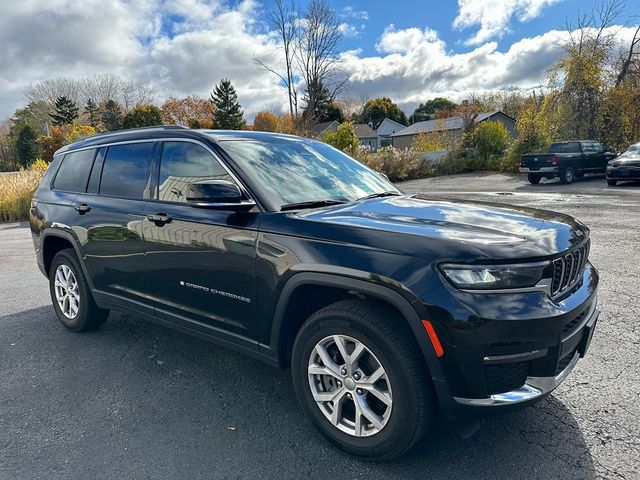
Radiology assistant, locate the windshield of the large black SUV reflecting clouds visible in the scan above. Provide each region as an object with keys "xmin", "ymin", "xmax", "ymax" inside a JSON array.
[{"xmin": 219, "ymin": 138, "xmax": 398, "ymax": 210}]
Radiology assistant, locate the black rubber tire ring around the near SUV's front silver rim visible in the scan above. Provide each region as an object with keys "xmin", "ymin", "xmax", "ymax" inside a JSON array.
[{"xmin": 292, "ymin": 313, "xmax": 428, "ymax": 457}]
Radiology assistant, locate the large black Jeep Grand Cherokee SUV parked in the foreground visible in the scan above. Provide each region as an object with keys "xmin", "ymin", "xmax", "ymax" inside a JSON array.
[{"xmin": 30, "ymin": 127, "xmax": 598, "ymax": 459}]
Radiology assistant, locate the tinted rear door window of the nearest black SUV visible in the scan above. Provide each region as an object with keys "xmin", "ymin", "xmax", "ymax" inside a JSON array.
[{"xmin": 100, "ymin": 143, "xmax": 153, "ymax": 199}]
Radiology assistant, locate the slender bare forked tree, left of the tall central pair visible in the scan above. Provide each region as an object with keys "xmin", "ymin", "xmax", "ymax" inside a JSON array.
[{"xmin": 254, "ymin": 0, "xmax": 298, "ymax": 119}]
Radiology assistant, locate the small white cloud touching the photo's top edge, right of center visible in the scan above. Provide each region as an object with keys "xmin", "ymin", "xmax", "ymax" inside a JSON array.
[{"xmin": 453, "ymin": 0, "xmax": 561, "ymax": 45}]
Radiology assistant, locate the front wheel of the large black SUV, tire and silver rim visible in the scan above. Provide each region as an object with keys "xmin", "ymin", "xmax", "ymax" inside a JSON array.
[{"xmin": 292, "ymin": 300, "xmax": 436, "ymax": 461}]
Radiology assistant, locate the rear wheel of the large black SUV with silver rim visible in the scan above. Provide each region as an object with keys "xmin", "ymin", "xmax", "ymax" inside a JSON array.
[{"xmin": 49, "ymin": 248, "xmax": 109, "ymax": 332}]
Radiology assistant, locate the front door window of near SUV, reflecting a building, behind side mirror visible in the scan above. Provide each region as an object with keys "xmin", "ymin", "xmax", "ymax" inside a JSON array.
[{"xmin": 158, "ymin": 142, "xmax": 233, "ymax": 202}]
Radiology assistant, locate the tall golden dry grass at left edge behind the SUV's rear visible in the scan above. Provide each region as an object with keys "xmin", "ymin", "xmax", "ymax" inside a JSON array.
[{"xmin": 0, "ymin": 170, "xmax": 44, "ymax": 222}]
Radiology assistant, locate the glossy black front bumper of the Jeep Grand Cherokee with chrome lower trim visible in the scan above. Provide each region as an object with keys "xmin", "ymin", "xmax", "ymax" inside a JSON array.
[{"xmin": 419, "ymin": 262, "xmax": 599, "ymax": 419}]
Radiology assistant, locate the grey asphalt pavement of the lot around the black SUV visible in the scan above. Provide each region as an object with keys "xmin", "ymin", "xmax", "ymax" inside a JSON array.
[{"xmin": 0, "ymin": 175, "xmax": 640, "ymax": 480}]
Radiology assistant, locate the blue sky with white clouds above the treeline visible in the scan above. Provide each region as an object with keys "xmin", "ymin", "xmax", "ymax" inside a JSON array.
[{"xmin": 0, "ymin": 0, "xmax": 640, "ymax": 121}]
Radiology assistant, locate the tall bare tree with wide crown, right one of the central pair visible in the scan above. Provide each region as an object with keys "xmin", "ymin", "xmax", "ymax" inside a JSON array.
[{"xmin": 295, "ymin": 0, "xmax": 347, "ymax": 121}]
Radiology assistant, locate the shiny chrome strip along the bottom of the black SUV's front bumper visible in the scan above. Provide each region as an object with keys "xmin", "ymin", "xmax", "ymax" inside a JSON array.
[{"xmin": 453, "ymin": 352, "xmax": 580, "ymax": 407}]
